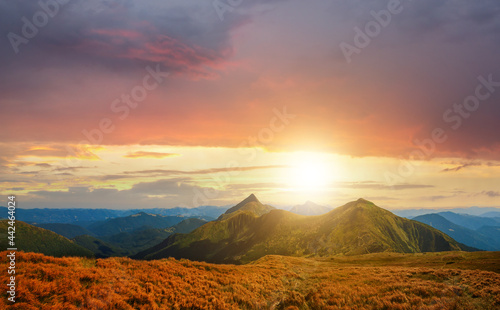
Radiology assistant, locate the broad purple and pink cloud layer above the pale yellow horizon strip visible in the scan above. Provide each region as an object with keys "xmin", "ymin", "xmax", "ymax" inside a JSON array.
[{"xmin": 0, "ymin": 0, "xmax": 500, "ymax": 158}]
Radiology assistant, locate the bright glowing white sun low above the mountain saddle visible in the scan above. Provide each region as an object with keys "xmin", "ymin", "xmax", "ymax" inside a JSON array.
[{"xmin": 286, "ymin": 152, "xmax": 336, "ymax": 191}]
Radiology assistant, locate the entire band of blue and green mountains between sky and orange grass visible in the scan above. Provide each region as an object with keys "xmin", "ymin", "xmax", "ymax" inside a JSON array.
[{"xmin": 0, "ymin": 194, "xmax": 500, "ymax": 263}]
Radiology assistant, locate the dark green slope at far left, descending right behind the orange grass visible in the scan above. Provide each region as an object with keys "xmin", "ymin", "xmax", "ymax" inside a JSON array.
[{"xmin": 0, "ymin": 220, "xmax": 94, "ymax": 257}]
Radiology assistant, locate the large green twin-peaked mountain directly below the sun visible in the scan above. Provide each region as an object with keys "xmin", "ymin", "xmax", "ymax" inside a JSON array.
[{"xmin": 135, "ymin": 197, "xmax": 467, "ymax": 263}]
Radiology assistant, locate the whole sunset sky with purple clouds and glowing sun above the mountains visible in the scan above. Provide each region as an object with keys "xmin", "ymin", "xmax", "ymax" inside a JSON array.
[{"xmin": 0, "ymin": 0, "xmax": 500, "ymax": 209}]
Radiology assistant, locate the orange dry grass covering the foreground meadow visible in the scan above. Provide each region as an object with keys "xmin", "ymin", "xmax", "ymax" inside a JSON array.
[{"xmin": 0, "ymin": 252, "xmax": 500, "ymax": 309}]
